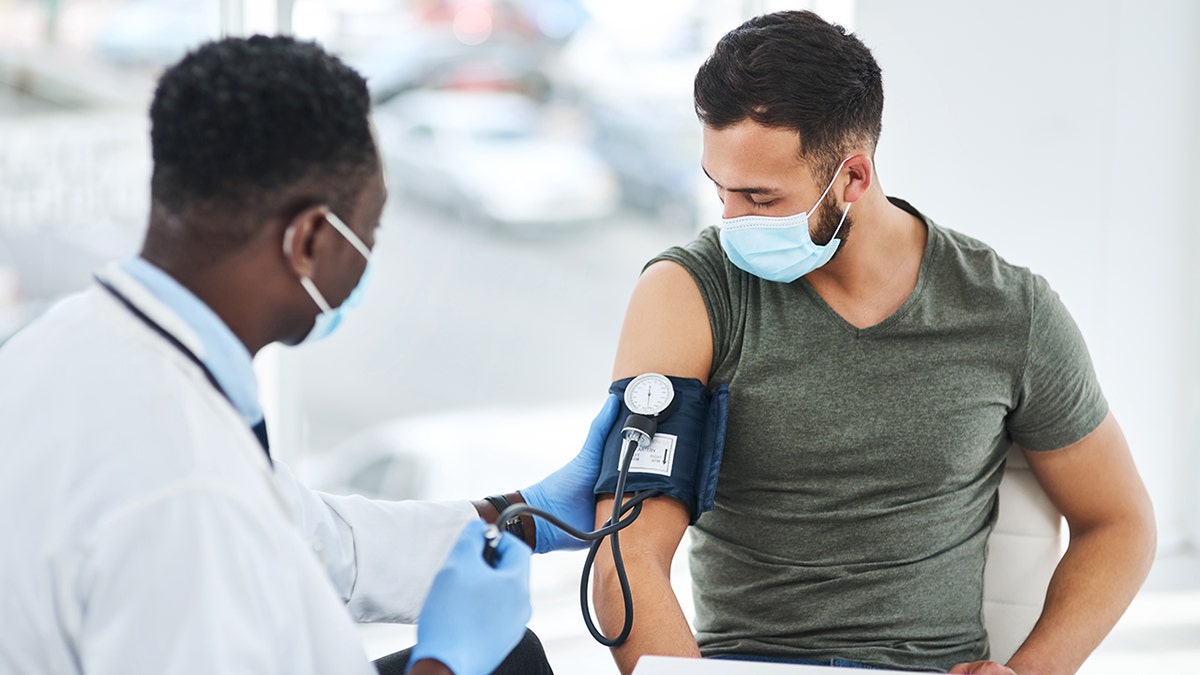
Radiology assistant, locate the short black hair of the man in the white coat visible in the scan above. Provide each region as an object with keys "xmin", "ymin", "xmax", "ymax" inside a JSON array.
[{"xmin": 150, "ymin": 35, "xmax": 378, "ymax": 230}]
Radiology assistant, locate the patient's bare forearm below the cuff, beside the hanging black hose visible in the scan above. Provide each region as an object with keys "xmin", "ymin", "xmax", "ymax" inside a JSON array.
[{"xmin": 593, "ymin": 543, "xmax": 700, "ymax": 675}]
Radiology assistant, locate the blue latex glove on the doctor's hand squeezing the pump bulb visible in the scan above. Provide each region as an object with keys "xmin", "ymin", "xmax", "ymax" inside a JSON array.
[{"xmin": 408, "ymin": 520, "xmax": 533, "ymax": 675}]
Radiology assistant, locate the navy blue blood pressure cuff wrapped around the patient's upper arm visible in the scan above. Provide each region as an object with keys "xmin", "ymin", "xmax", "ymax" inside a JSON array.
[{"xmin": 595, "ymin": 377, "xmax": 730, "ymax": 525}]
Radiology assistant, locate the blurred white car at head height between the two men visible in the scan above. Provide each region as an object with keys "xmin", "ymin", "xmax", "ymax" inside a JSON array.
[{"xmin": 376, "ymin": 90, "xmax": 620, "ymax": 228}]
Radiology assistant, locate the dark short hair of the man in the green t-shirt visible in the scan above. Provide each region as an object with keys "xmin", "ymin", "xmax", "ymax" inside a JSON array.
[{"xmin": 695, "ymin": 11, "xmax": 883, "ymax": 182}]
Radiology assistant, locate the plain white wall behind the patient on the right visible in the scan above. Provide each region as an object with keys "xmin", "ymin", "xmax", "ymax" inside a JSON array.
[{"xmin": 854, "ymin": 0, "xmax": 1200, "ymax": 549}]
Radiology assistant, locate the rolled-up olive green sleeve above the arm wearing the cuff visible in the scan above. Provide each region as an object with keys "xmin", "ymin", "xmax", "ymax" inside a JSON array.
[{"xmin": 646, "ymin": 227, "xmax": 736, "ymax": 365}]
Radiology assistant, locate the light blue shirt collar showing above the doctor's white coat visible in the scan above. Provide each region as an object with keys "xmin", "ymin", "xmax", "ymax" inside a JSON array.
[{"xmin": 121, "ymin": 257, "xmax": 263, "ymax": 426}]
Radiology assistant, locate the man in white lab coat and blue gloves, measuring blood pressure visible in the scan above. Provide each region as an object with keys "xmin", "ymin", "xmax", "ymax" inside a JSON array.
[{"xmin": 0, "ymin": 36, "xmax": 616, "ymax": 675}]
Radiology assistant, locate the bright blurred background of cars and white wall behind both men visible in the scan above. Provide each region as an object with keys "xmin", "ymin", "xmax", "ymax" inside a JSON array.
[{"xmin": 0, "ymin": 0, "xmax": 1200, "ymax": 674}]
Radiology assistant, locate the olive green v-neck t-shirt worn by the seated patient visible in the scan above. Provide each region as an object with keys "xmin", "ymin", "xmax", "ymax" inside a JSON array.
[{"xmin": 652, "ymin": 199, "xmax": 1108, "ymax": 669}]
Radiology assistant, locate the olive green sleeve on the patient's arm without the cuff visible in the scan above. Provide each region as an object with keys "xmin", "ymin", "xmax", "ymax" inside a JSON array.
[{"xmin": 1008, "ymin": 275, "xmax": 1109, "ymax": 450}]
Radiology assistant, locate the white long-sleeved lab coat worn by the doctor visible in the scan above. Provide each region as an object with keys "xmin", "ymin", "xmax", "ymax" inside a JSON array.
[{"xmin": 0, "ymin": 268, "xmax": 476, "ymax": 675}]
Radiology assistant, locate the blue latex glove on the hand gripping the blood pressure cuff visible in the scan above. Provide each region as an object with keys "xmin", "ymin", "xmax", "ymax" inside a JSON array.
[{"xmin": 521, "ymin": 394, "xmax": 620, "ymax": 554}]
